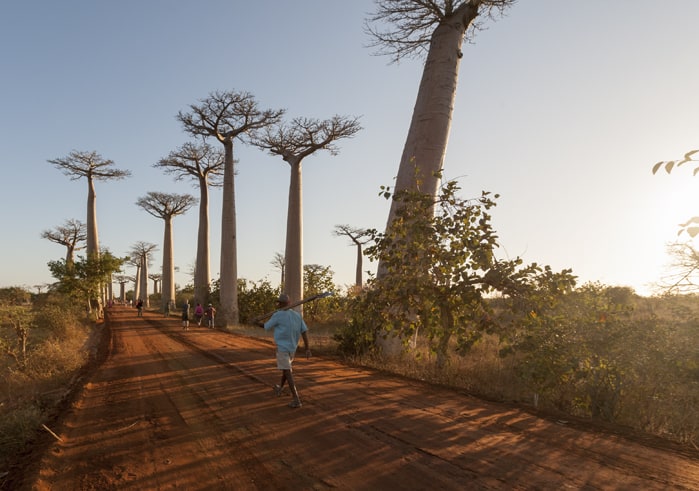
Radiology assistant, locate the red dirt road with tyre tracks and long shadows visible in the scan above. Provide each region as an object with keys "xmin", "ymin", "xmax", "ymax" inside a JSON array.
[{"xmin": 9, "ymin": 309, "xmax": 699, "ymax": 491}]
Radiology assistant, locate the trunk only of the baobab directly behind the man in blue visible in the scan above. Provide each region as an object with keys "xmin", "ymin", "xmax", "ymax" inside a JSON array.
[{"xmin": 284, "ymin": 158, "xmax": 303, "ymax": 312}]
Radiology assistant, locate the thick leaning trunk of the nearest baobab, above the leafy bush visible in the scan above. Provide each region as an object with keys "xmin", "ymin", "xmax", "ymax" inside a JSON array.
[{"xmin": 388, "ymin": 8, "xmax": 478, "ymax": 231}]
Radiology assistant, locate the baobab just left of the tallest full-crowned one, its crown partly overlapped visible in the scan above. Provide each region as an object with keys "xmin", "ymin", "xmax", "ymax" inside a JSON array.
[{"xmin": 154, "ymin": 142, "xmax": 224, "ymax": 304}]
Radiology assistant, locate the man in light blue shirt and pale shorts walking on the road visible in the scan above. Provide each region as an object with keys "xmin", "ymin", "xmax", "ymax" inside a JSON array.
[{"xmin": 262, "ymin": 293, "xmax": 311, "ymax": 408}]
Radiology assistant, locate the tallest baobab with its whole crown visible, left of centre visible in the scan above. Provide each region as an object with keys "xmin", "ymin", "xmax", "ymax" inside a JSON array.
[{"xmin": 177, "ymin": 91, "xmax": 284, "ymax": 326}]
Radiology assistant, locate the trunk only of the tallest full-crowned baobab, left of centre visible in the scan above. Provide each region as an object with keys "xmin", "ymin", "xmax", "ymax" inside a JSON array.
[{"xmin": 218, "ymin": 138, "xmax": 239, "ymax": 326}]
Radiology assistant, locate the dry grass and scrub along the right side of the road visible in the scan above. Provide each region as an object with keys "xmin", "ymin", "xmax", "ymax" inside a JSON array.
[{"xmin": 335, "ymin": 284, "xmax": 699, "ymax": 448}]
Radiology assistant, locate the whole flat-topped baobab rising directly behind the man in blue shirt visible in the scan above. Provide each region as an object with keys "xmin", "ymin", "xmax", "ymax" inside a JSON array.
[{"xmin": 254, "ymin": 115, "xmax": 362, "ymax": 311}]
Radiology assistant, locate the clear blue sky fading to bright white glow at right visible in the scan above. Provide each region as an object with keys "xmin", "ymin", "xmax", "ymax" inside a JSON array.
[{"xmin": 0, "ymin": 0, "xmax": 699, "ymax": 294}]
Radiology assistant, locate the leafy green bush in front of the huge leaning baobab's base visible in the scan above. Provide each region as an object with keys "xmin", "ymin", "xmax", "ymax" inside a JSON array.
[{"xmin": 351, "ymin": 181, "xmax": 575, "ymax": 360}]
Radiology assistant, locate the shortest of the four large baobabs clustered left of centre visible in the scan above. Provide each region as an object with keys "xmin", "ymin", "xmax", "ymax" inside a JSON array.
[{"xmin": 136, "ymin": 191, "xmax": 197, "ymax": 312}]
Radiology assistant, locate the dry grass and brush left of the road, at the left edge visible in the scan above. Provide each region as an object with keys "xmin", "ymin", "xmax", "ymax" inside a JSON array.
[{"xmin": 0, "ymin": 294, "xmax": 95, "ymax": 474}]
